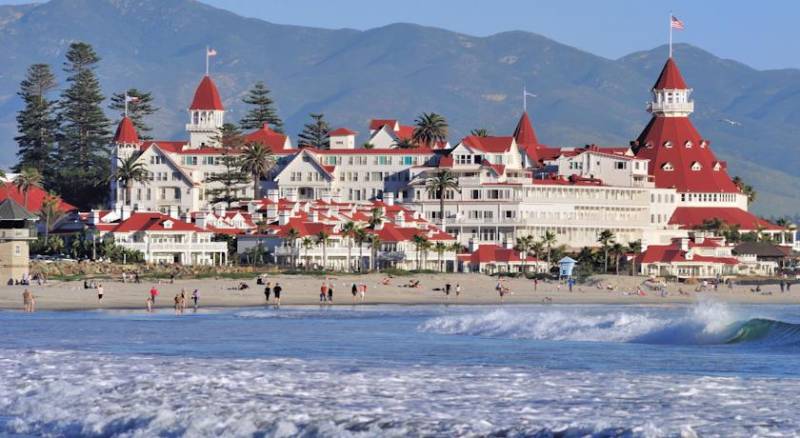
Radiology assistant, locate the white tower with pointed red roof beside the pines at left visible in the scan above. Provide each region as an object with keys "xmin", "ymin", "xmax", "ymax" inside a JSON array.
[{"xmin": 186, "ymin": 75, "xmax": 225, "ymax": 149}]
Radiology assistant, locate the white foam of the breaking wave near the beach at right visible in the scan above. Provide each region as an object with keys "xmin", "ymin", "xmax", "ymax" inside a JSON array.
[{"xmin": 420, "ymin": 301, "xmax": 736, "ymax": 344}]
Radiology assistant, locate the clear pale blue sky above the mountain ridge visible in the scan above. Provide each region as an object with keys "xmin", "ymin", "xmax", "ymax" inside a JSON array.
[{"xmin": 0, "ymin": 0, "xmax": 800, "ymax": 69}]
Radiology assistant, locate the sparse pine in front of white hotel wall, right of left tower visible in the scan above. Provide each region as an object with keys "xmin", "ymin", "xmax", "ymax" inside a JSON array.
[{"xmin": 206, "ymin": 123, "xmax": 250, "ymax": 202}]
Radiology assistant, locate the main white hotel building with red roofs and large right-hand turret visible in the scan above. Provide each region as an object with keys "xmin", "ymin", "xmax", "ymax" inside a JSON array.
[{"xmin": 111, "ymin": 58, "xmax": 780, "ymax": 262}]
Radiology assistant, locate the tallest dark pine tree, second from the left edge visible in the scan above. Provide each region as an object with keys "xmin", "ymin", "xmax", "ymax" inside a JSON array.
[{"xmin": 55, "ymin": 42, "xmax": 110, "ymax": 208}]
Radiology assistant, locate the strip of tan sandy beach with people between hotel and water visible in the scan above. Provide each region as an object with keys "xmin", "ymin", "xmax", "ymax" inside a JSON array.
[{"xmin": 0, "ymin": 274, "xmax": 800, "ymax": 310}]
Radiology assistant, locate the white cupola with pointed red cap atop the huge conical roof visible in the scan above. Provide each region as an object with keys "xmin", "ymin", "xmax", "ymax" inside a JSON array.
[{"xmin": 647, "ymin": 58, "xmax": 694, "ymax": 117}]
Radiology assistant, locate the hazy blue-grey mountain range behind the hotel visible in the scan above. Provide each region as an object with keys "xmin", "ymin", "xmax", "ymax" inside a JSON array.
[{"xmin": 0, "ymin": 0, "xmax": 800, "ymax": 216}]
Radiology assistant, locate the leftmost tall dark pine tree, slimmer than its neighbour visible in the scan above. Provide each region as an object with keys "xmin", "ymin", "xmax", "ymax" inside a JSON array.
[{"xmin": 14, "ymin": 64, "xmax": 58, "ymax": 184}]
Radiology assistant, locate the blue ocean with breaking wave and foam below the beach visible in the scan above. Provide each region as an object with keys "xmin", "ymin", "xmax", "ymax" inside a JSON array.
[{"xmin": 0, "ymin": 301, "xmax": 800, "ymax": 437}]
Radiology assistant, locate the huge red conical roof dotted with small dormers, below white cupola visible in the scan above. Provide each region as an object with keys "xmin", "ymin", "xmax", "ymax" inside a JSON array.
[{"xmin": 636, "ymin": 116, "xmax": 739, "ymax": 193}]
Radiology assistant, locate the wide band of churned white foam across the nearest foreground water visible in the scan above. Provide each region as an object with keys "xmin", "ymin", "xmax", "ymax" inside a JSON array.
[{"xmin": 0, "ymin": 350, "xmax": 800, "ymax": 437}]
